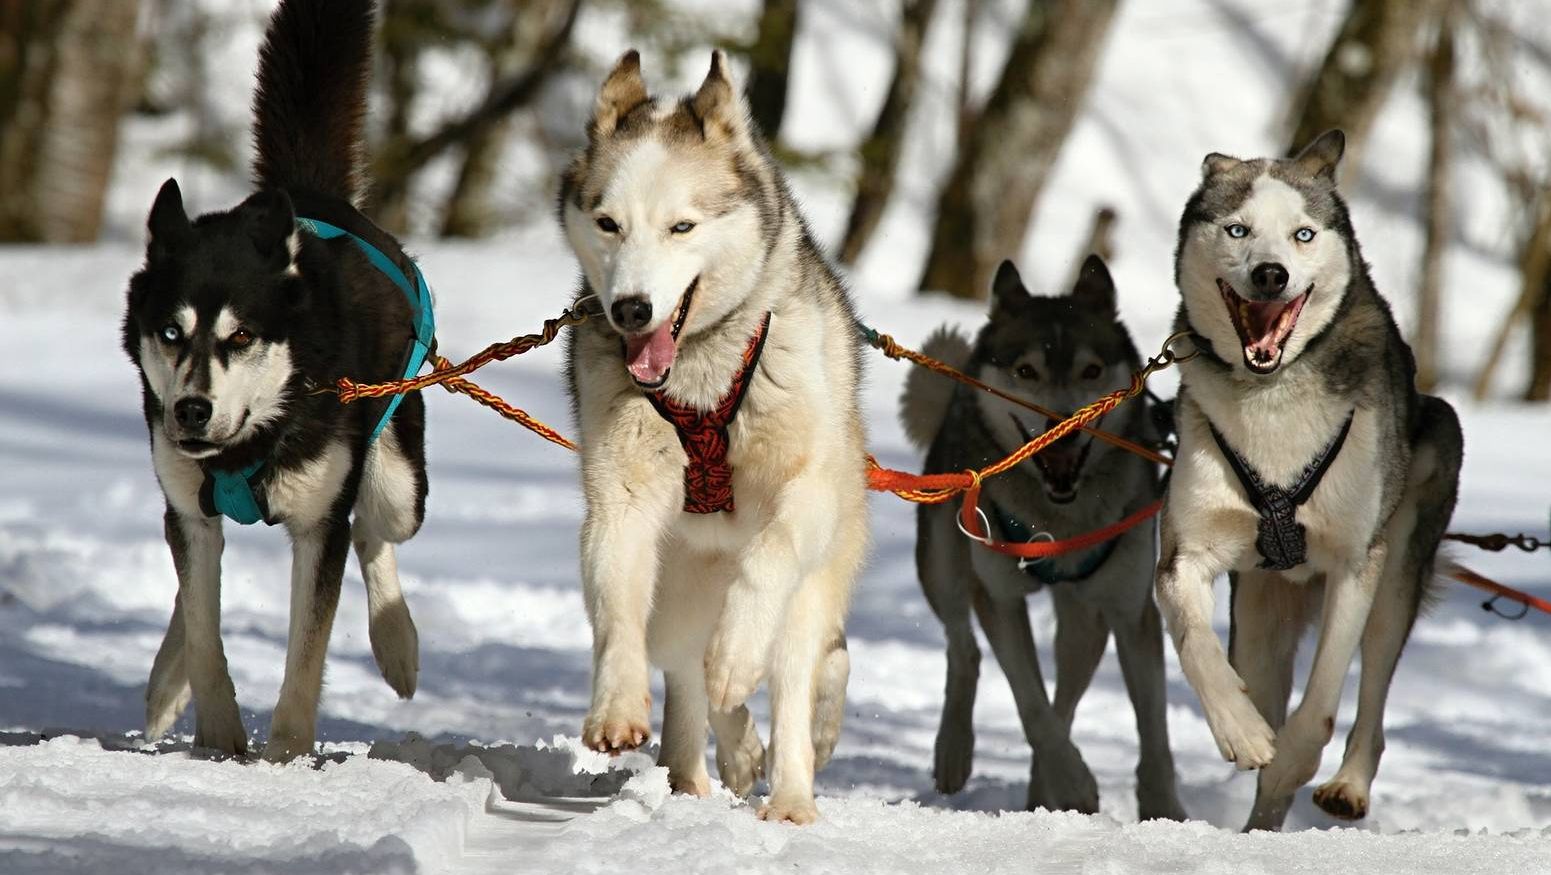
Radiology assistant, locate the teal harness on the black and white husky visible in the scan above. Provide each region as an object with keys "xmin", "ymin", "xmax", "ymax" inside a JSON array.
[{"xmin": 200, "ymin": 192, "xmax": 436, "ymax": 526}]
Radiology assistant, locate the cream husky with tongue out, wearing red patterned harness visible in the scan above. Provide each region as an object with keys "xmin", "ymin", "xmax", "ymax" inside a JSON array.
[{"xmin": 560, "ymin": 51, "xmax": 867, "ymax": 822}]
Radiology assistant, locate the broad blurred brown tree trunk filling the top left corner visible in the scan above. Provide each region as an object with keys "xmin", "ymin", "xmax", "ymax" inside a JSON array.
[{"xmin": 0, "ymin": 0, "xmax": 141, "ymax": 242}]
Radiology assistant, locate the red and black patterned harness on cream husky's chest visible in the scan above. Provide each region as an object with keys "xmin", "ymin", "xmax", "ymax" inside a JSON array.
[{"xmin": 647, "ymin": 313, "xmax": 771, "ymax": 514}]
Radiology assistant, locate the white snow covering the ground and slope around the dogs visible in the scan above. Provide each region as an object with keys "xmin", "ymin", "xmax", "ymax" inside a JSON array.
[{"xmin": 0, "ymin": 0, "xmax": 1551, "ymax": 873}]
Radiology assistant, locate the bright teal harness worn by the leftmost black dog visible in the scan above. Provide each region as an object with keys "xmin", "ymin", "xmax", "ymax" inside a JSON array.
[{"xmin": 200, "ymin": 209, "xmax": 436, "ymax": 526}]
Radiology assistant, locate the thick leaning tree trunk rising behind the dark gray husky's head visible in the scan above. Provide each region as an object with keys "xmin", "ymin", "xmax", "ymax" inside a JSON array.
[{"xmin": 920, "ymin": 0, "xmax": 1118, "ymax": 298}]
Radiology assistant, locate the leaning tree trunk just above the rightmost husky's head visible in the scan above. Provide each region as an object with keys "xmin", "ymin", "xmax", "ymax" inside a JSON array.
[{"xmin": 1287, "ymin": 0, "xmax": 1436, "ymax": 168}]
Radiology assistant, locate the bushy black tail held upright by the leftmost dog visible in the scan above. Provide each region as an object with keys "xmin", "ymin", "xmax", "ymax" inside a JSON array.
[{"xmin": 253, "ymin": 0, "xmax": 375, "ymax": 203}]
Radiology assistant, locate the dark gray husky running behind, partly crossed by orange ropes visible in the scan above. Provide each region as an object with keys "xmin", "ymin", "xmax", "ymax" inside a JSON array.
[{"xmin": 901, "ymin": 256, "xmax": 1185, "ymax": 819}]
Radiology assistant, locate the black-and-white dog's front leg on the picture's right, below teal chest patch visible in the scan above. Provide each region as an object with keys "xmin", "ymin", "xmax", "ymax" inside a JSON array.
[{"xmin": 264, "ymin": 517, "xmax": 351, "ymax": 763}]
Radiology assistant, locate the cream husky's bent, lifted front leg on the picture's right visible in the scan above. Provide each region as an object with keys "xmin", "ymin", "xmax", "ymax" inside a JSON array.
[{"xmin": 706, "ymin": 518, "xmax": 802, "ymax": 712}]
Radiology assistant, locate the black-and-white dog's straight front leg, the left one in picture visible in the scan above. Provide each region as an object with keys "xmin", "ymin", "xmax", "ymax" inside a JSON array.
[{"xmin": 162, "ymin": 509, "xmax": 248, "ymax": 756}]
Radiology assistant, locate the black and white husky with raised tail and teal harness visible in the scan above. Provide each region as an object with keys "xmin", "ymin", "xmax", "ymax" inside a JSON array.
[{"xmin": 124, "ymin": 0, "xmax": 427, "ymax": 760}]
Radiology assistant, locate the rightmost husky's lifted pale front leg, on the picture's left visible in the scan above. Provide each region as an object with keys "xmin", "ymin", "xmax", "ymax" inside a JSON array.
[{"xmin": 1157, "ymin": 539, "xmax": 1276, "ymax": 770}]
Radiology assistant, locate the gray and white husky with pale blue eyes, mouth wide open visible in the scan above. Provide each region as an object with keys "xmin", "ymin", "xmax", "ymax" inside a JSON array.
[{"xmin": 1157, "ymin": 130, "xmax": 1463, "ymax": 828}]
